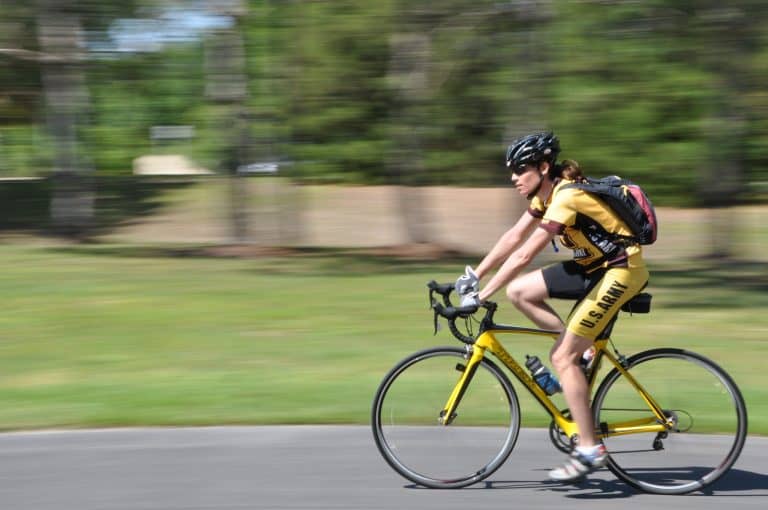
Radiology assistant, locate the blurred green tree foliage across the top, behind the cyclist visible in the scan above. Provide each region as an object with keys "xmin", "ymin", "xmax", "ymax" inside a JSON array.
[{"xmin": 0, "ymin": 0, "xmax": 768, "ymax": 205}]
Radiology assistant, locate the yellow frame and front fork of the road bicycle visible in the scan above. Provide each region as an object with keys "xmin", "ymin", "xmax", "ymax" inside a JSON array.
[{"xmin": 440, "ymin": 327, "xmax": 673, "ymax": 438}]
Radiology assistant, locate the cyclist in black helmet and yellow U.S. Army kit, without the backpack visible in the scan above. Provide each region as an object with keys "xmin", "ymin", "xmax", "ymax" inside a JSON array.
[{"xmin": 456, "ymin": 133, "xmax": 648, "ymax": 481}]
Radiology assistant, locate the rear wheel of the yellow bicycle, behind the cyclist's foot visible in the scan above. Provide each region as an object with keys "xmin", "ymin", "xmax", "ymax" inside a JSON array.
[{"xmin": 592, "ymin": 348, "xmax": 747, "ymax": 494}]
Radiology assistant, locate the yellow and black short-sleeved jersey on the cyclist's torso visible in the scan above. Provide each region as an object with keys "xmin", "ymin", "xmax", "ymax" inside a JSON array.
[{"xmin": 528, "ymin": 180, "xmax": 645, "ymax": 271}]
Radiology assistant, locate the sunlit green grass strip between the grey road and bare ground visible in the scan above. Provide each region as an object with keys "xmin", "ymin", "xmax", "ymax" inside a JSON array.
[{"xmin": 0, "ymin": 244, "xmax": 768, "ymax": 434}]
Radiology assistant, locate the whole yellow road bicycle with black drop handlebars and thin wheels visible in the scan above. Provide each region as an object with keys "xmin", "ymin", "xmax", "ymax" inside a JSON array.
[{"xmin": 371, "ymin": 281, "xmax": 747, "ymax": 494}]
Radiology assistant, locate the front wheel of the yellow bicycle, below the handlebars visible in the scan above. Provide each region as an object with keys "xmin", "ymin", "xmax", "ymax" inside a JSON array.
[{"xmin": 371, "ymin": 347, "xmax": 520, "ymax": 489}]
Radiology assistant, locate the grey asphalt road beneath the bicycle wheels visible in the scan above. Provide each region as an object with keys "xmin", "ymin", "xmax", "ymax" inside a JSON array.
[{"xmin": 0, "ymin": 426, "xmax": 768, "ymax": 510}]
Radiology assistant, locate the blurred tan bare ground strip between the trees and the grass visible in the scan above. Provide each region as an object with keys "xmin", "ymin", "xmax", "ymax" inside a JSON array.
[{"xmin": 99, "ymin": 179, "xmax": 768, "ymax": 261}]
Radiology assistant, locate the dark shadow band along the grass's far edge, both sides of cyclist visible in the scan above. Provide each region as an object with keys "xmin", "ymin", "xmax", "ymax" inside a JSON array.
[{"xmin": 40, "ymin": 243, "xmax": 768, "ymax": 294}]
